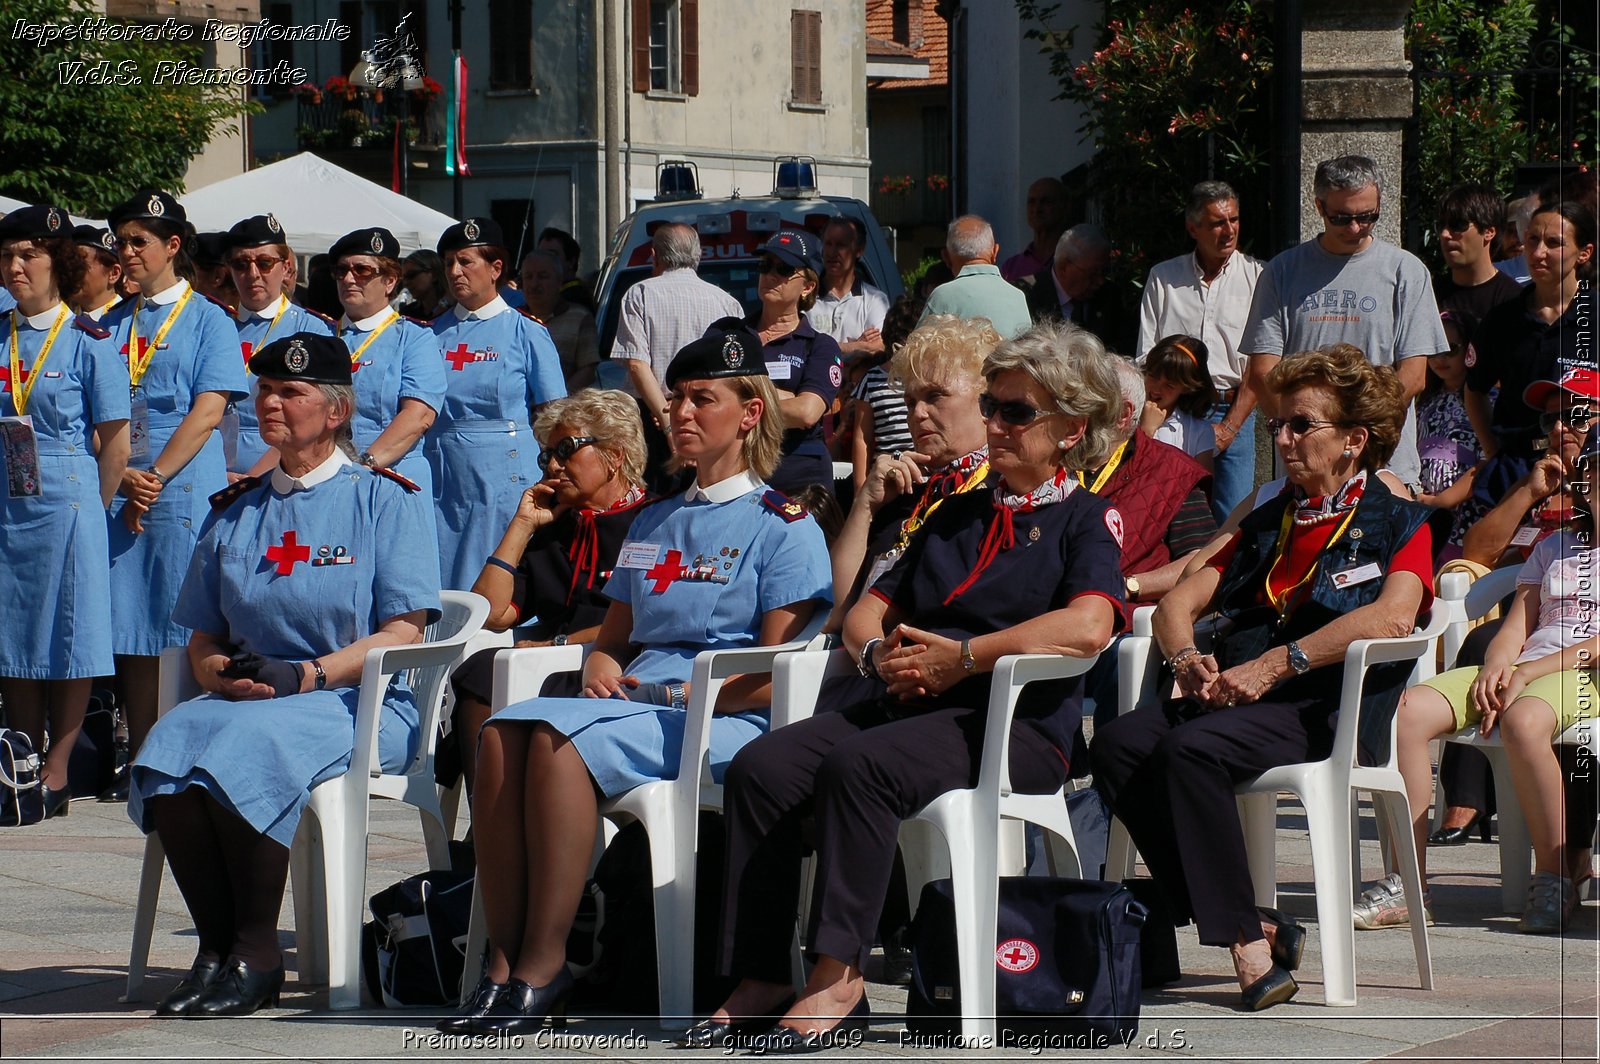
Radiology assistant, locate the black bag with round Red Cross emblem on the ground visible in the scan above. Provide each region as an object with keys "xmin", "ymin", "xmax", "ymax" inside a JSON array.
[{"xmin": 906, "ymin": 877, "xmax": 1147, "ymax": 1050}]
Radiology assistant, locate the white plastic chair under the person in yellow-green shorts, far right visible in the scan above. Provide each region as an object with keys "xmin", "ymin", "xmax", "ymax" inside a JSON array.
[{"xmin": 1434, "ymin": 565, "xmax": 1595, "ymax": 914}]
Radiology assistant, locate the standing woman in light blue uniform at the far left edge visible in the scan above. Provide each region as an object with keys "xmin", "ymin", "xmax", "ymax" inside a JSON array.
[{"xmin": 0, "ymin": 206, "xmax": 128, "ymax": 818}]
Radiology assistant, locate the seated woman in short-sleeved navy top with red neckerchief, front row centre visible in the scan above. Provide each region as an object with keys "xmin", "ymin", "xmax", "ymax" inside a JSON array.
[{"xmin": 688, "ymin": 316, "xmax": 1122, "ymax": 1050}]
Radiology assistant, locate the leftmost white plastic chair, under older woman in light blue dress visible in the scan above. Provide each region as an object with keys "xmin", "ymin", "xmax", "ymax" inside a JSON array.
[{"xmin": 125, "ymin": 590, "xmax": 490, "ymax": 1010}]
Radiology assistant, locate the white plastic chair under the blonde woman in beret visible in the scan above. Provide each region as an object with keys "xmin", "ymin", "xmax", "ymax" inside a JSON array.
[{"xmin": 461, "ymin": 624, "xmax": 827, "ymax": 1030}]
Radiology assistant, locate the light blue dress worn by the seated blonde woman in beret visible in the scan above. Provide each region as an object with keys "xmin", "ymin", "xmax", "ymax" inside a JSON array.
[{"xmin": 490, "ymin": 485, "xmax": 834, "ymax": 798}]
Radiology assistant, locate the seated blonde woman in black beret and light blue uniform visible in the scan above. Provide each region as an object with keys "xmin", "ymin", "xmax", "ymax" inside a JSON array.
[{"xmin": 440, "ymin": 318, "xmax": 832, "ymax": 1034}]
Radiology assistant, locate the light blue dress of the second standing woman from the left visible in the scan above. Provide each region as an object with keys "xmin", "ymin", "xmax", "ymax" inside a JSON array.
[{"xmin": 101, "ymin": 281, "xmax": 246, "ymax": 656}]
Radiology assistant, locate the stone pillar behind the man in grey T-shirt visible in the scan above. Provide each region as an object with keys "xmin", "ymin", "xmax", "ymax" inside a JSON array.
[{"xmin": 1301, "ymin": 0, "xmax": 1411, "ymax": 245}]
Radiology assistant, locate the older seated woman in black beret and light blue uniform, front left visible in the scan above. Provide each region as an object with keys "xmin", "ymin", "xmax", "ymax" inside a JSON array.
[{"xmin": 128, "ymin": 333, "xmax": 438, "ymax": 1016}]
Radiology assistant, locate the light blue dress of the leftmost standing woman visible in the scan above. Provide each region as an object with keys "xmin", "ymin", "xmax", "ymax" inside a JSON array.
[{"xmin": 0, "ymin": 304, "xmax": 128, "ymax": 680}]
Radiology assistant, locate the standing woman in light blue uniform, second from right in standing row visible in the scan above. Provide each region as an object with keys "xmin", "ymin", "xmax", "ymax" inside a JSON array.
[{"xmin": 328, "ymin": 229, "xmax": 445, "ymax": 499}]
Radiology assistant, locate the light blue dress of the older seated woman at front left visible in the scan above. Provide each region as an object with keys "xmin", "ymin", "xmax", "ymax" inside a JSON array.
[{"xmin": 128, "ymin": 464, "xmax": 438, "ymax": 846}]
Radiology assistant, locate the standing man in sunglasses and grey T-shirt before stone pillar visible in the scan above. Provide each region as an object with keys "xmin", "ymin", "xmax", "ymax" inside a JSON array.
[{"xmin": 1219, "ymin": 155, "xmax": 1450, "ymax": 485}]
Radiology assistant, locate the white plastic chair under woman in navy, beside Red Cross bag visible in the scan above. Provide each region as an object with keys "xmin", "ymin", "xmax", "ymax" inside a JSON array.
[{"xmin": 773, "ymin": 640, "xmax": 1098, "ymax": 1045}]
